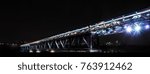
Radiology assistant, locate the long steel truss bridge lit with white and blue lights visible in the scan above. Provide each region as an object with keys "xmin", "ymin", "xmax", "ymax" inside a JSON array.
[{"xmin": 20, "ymin": 8, "xmax": 150, "ymax": 52}]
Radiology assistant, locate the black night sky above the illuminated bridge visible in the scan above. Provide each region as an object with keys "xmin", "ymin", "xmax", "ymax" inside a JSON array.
[{"xmin": 0, "ymin": 0, "xmax": 150, "ymax": 42}]
